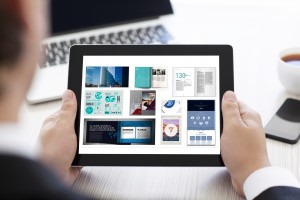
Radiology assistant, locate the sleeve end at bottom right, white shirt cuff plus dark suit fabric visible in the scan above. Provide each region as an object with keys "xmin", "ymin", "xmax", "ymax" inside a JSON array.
[{"xmin": 244, "ymin": 167, "xmax": 300, "ymax": 200}]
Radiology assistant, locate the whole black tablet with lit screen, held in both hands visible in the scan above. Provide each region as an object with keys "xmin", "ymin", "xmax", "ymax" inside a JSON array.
[{"xmin": 68, "ymin": 45, "xmax": 233, "ymax": 166}]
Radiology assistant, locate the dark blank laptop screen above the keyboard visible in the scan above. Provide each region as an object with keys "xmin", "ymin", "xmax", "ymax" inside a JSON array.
[{"xmin": 51, "ymin": 0, "xmax": 173, "ymax": 35}]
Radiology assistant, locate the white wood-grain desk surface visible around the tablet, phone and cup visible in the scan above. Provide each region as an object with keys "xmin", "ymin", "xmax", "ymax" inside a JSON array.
[{"xmin": 21, "ymin": 0, "xmax": 300, "ymax": 199}]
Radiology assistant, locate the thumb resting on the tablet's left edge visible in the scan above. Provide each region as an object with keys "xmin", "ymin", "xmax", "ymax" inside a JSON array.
[{"xmin": 60, "ymin": 90, "xmax": 77, "ymax": 127}]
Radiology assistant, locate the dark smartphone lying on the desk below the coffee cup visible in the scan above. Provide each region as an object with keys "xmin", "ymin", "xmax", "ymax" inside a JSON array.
[{"xmin": 265, "ymin": 99, "xmax": 300, "ymax": 144}]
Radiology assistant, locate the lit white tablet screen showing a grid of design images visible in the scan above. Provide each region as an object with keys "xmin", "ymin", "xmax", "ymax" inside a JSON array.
[{"xmin": 78, "ymin": 55, "xmax": 220, "ymax": 155}]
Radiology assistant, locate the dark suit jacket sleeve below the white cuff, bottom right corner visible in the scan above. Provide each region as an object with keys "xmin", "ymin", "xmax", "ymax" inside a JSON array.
[{"xmin": 255, "ymin": 186, "xmax": 300, "ymax": 200}]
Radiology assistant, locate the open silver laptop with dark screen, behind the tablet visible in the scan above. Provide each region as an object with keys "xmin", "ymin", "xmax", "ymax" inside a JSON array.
[{"xmin": 27, "ymin": 0, "xmax": 175, "ymax": 104}]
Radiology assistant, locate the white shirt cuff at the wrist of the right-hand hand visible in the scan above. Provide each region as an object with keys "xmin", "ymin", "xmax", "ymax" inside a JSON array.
[{"xmin": 243, "ymin": 167, "xmax": 300, "ymax": 199}]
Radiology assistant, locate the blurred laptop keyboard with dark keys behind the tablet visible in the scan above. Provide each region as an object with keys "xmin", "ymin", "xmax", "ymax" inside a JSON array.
[{"xmin": 39, "ymin": 25, "xmax": 173, "ymax": 68}]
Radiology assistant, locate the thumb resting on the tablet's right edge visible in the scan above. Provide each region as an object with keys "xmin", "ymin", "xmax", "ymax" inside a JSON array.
[{"xmin": 222, "ymin": 91, "xmax": 242, "ymax": 125}]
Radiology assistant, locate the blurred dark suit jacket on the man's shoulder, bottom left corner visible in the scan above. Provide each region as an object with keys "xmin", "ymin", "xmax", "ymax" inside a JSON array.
[{"xmin": 0, "ymin": 155, "xmax": 90, "ymax": 200}]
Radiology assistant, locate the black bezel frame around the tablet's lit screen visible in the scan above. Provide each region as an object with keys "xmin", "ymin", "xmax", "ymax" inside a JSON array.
[{"xmin": 68, "ymin": 45, "xmax": 234, "ymax": 166}]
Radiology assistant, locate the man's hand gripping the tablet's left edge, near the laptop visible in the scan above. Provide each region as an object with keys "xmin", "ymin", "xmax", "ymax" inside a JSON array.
[{"xmin": 40, "ymin": 90, "xmax": 80, "ymax": 183}]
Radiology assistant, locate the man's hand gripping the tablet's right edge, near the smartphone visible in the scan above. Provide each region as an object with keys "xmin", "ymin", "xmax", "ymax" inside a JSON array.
[{"xmin": 221, "ymin": 91, "xmax": 270, "ymax": 196}]
